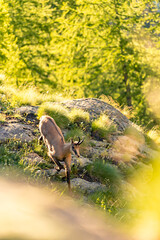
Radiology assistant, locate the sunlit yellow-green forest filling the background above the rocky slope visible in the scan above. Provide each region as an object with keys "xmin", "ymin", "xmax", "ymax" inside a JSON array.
[{"xmin": 0, "ymin": 0, "xmax": 160, "ymax": 129}]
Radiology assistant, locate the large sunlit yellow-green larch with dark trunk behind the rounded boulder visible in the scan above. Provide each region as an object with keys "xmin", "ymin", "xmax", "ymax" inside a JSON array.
[{"xmin": 51, "ymin": 0, "xmax": 159, "ymax": 123}]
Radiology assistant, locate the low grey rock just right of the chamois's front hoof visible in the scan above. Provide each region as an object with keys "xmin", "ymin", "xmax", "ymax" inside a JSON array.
[{"xmin": 71, "ymin": 178, "xmax": 105, "ymax": 194}]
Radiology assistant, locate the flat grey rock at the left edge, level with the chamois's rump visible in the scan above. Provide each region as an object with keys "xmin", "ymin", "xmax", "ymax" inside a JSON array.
[{"xmin": 0, "ymin": 123, "xmax": 34, "ymax": 142}]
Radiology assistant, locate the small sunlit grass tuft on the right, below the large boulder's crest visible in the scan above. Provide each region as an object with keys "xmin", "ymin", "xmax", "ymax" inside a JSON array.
[{"xmin": 92, "ymin": 114, "xmax": 116, "ymax": 139}]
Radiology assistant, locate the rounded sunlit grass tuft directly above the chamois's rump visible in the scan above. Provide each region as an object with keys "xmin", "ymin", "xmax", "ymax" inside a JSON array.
[{"xmin": 38, "ymin": 102, "xmax": 70, "ymax": 128}]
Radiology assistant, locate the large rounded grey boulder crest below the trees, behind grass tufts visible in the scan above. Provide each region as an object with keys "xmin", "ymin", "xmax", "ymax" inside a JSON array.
[{"xmin": 61, "ymin": 98, "xmax": 132, "ymax": 132}]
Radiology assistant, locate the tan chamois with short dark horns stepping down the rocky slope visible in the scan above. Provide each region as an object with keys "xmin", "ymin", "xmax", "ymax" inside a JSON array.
[{"xmin": 39, "ymin": 116, "xmax": 84, "ymax": 190}]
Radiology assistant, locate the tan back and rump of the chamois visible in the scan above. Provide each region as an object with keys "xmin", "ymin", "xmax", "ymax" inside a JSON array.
[{"xmin": 39, "ymin": 115, "xmax": 65, "ymax": 147}]
